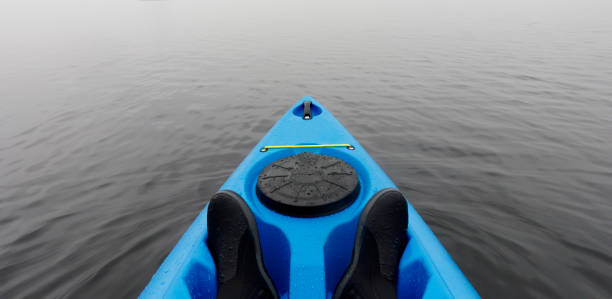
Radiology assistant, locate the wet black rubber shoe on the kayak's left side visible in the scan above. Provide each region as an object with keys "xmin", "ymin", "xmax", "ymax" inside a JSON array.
[{"xmin": 207, "ymin": 191, "xmax": 278, "ymax": 299}]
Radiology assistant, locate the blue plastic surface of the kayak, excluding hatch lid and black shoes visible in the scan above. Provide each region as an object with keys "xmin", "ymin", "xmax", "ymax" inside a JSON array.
[{"xmin": 140, "ymin": 97, "xmax": 479, "ymax": 299}]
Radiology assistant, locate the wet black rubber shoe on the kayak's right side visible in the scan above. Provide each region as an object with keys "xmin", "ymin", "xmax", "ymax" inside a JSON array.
[{"xmin": 333, "ymin": 189, "xmax": 408, "ymax": 299}]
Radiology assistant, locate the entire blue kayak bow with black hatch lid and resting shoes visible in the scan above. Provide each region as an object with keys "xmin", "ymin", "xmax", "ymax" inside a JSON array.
[{"xmin": 140, "ymin": 97, "xmax": 479, "ymax": 299}]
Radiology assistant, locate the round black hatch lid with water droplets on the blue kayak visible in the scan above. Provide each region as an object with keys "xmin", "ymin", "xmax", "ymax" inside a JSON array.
[{"xmin": 256, "ymin": 153, "xmax": 359, "ymax": 217}]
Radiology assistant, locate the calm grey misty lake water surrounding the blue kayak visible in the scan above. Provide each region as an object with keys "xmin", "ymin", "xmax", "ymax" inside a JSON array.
[{"xmin": 0, "ymin": 0, "xmax": 612, "ymax": 298}]
